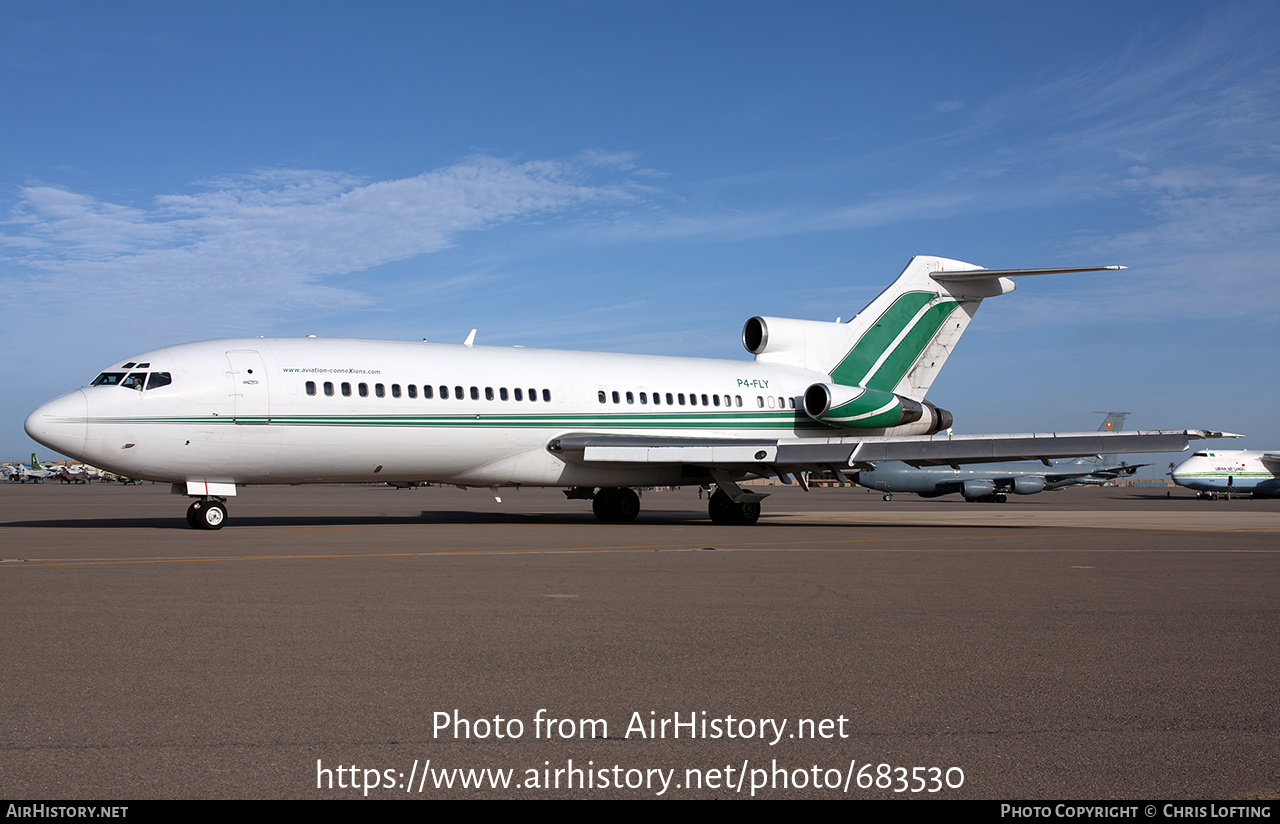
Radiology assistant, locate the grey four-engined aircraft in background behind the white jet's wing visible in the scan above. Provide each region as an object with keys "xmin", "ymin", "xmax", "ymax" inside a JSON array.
[{"xmin": 851, "ymin": 412, "xmax": 1147, "ymax": 504}]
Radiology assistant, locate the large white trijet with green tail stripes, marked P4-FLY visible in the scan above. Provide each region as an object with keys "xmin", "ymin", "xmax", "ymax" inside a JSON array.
[{"xmin": 26, "ymin": 256, "xmax": 1228, "ymax": 528}]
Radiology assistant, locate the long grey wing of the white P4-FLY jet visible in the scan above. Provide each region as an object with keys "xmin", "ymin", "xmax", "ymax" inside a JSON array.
[{"xmin": 548, "ymin": 430, "xmax": 1230, "ymax": 475}]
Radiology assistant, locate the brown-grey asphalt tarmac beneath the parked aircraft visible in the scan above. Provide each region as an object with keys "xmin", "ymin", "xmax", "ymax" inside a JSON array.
[{"xmin": 0, "ymin": 484, "xmax": 1280, "ymax": 802}]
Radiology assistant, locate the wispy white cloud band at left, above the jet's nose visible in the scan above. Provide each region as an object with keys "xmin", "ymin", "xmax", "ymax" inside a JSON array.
[{"xmin": 0, "ymin": 152, "xmax": 648, "ymax": 324}]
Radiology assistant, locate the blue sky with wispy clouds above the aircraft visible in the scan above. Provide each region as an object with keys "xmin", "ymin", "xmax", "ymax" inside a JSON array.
[{"xmin": 0, "ymin": 0, "xmax": 1280, "ymax": 462}]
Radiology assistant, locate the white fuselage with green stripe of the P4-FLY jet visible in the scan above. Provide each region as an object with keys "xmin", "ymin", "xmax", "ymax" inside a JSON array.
[{"xmin": 27, "ymin": 338, "xmax": 927, "ymax": 486}]
